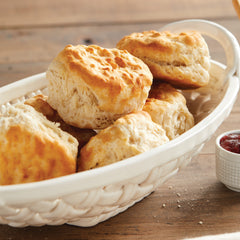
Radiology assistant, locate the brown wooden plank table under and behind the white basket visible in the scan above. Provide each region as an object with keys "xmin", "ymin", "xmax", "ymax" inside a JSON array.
[{"xmin": 0, "ymin": 0, "xmax": 240, "ymax": 240}]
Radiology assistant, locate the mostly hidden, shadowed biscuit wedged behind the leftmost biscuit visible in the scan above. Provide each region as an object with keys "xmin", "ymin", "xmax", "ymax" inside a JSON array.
[{"xmin": 24, "ymin": 94, "xmax": 96, "ymax": 151}]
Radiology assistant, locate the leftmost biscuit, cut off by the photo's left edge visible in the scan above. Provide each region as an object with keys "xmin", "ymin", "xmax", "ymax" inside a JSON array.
[{"xmin": 0, "ymin": 104, "xmax": 78, "ymax": 185}]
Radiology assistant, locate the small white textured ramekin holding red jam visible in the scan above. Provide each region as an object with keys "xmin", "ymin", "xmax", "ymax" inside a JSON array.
[{"xmin": 216, "ymin": 130, "xmax": 240, "ymax": 192}]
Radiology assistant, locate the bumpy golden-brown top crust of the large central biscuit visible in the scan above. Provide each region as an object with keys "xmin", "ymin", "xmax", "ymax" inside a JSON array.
[{"xmin": 53, "ymin": 45, "xmax": 152, "ymax": 108}]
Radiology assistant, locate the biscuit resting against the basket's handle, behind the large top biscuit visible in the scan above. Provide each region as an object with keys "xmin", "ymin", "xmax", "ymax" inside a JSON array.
[{"xmin": 117, "ymin": 30, "xmax": 210, "ymax": 89}]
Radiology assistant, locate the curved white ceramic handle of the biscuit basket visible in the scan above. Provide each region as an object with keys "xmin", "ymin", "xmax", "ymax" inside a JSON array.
[{"xmin": 160, "ymin": 19, "xmax": 240, "ymax": 83}]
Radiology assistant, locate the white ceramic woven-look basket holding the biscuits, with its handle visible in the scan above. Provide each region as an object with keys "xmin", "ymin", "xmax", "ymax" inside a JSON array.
[{"xmin": 0, "ymin": 20, "xmax": 239, "ymax": 227}]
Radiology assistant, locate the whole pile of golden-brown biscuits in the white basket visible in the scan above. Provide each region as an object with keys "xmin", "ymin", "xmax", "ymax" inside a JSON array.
[{"xmin": 0, "ymin": 31, "xmax": 210, "ymax": 185}]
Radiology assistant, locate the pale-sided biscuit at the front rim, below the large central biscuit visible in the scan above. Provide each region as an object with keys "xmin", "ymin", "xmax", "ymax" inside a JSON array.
[{"xmin": 78, "ymin": 111, "xmax": 169, "ymax": 171}]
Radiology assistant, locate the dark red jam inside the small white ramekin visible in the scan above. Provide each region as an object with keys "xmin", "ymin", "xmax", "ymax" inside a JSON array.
[{"xmin": 220, "ymin": 133, "xmax": 240, "ymax": 153}]
